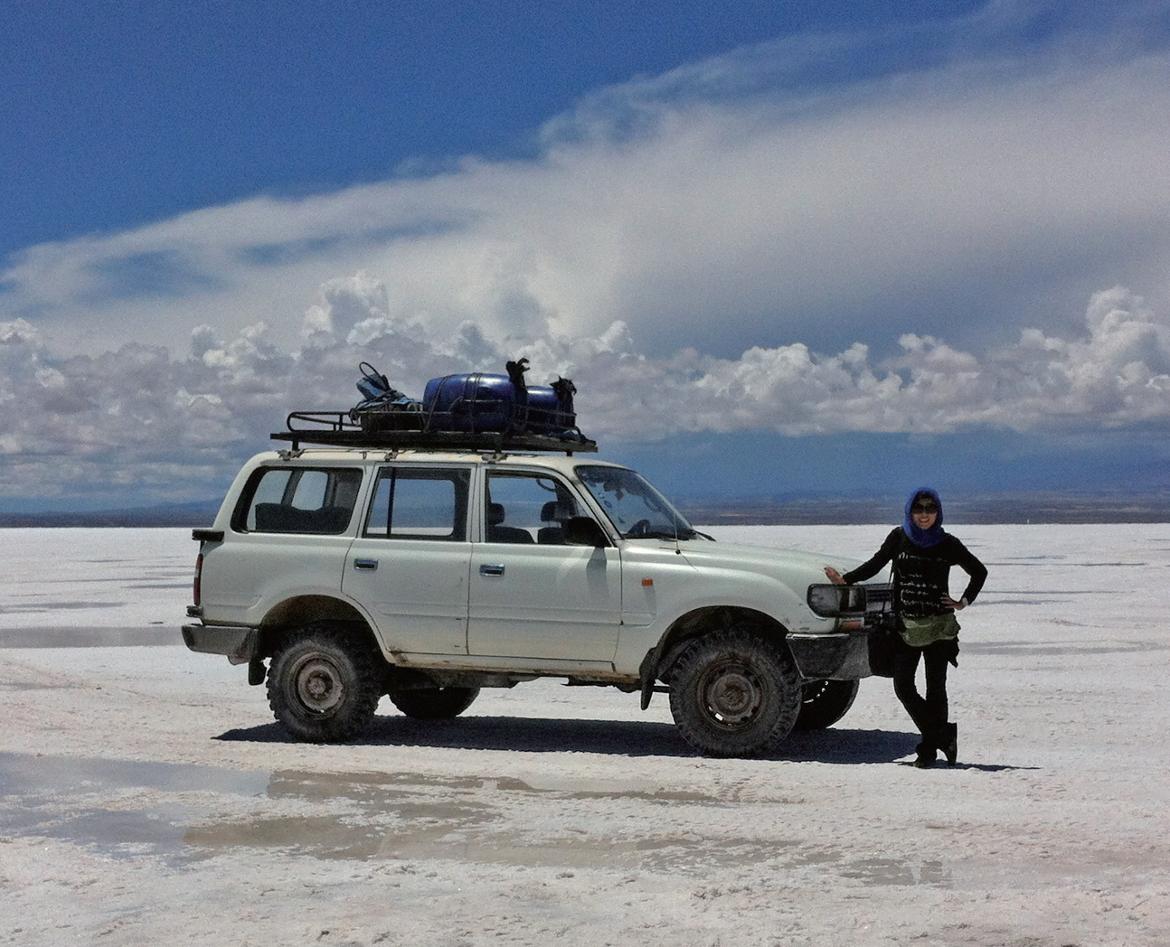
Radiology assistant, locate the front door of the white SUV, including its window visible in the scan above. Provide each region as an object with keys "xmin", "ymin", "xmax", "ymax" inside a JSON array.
[{"xmin": 468, "ymin": 469, "xmax": 621, "ymax": 668}]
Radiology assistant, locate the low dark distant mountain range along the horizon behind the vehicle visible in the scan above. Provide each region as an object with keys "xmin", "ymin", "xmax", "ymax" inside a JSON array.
[{"xmin": 0, "ymin": 490, "xmax": 1170, "ymax": 527}]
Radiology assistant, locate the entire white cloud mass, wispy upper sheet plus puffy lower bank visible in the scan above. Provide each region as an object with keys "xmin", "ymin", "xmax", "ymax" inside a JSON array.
[{"xmin": 0, "ymin": 12, "xmax": 1170, "ymax": 499}]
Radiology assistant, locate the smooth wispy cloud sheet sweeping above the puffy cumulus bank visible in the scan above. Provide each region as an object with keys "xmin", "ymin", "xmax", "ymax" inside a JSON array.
[{"xmin": 0, "ymin": 16, "xmax": 1170, "ymax": 358}]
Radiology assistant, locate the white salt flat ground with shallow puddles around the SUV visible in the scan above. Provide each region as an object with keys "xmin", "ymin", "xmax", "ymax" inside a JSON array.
[{"xmin": 0, "ymin": 524, "xmax": 1170, "ymax": 947}]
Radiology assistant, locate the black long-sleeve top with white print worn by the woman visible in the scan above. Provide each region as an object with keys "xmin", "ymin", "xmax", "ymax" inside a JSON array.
[{"xmin": 842, "ymin": 527, "xmax": 987, "ymax": 618}]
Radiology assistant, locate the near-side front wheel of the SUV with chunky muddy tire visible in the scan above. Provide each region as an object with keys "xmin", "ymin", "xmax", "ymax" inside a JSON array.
[{"xmin": 670, "ymin": 626, "xmax": 800, "ymax": 756}]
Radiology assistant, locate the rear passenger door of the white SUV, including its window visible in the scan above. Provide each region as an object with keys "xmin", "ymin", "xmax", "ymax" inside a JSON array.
[{"xmin": 342, "ymin": 464, "xmax": 472, "ymax": 654}]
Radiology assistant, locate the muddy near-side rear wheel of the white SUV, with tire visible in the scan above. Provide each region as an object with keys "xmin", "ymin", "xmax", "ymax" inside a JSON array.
[{"xmin": 268, "ymin": 622, "xmax": 384, "ymax": 743}]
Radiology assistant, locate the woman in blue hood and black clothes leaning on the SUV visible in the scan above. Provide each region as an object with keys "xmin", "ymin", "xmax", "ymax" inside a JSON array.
[{"xmin": 825, "ymin": 487, "xmax": 987, "ymax": 767}]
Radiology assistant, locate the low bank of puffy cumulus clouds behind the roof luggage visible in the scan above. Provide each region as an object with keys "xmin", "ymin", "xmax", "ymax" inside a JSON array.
[{"xmin": 0, "ymin": 274, "xmax": 1170, "ymax": 499}]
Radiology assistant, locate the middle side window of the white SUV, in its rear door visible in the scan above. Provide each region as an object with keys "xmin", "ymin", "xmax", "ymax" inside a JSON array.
[{"xmin": 363, "ymin": 467, "xmax": 470, "ymax": 542}]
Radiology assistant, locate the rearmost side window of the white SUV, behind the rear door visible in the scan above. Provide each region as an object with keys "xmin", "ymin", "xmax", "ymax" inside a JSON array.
[{"xmin": 232, "ymin": 467, "xmax": 362, "ymax": 535}]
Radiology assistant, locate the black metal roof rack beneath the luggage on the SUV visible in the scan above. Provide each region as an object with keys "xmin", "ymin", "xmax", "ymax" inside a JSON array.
[{"xmin": 271, "ymin": 411, "xmax": 597, "ymax": 454}]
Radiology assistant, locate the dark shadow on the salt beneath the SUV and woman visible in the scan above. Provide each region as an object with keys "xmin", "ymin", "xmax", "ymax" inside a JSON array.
[{"xmin": 214, "ymin": 715, "xmax": 1017, "ymax": 771}]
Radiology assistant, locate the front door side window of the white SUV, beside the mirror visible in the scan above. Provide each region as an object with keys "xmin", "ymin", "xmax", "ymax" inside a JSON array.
[{"xmin": 483, "ymin": 472, "xmax": 580, "ymax": 545}]
